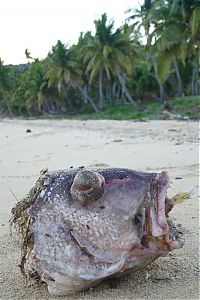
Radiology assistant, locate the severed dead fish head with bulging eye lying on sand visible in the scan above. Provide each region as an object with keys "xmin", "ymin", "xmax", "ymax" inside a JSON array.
[{"xmin": 13, "ymin": 167, "xmax": 188, "ymax": 295}]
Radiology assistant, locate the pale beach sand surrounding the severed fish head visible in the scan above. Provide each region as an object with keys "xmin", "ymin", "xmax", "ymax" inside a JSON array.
[{"xmin": 0, "ymin": 119, "xmax": 199, "ymax": 300}]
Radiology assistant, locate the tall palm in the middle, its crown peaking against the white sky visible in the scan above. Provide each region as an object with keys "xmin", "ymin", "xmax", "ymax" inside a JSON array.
[{"xmin": 84, "ymin": 13, "xmax": 138, "ymax": 109}]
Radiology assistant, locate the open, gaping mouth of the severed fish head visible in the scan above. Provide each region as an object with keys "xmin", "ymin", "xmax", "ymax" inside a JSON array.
[{"xmin": 142, "ymin": 171, "xmax": 184, "ymax": 251}]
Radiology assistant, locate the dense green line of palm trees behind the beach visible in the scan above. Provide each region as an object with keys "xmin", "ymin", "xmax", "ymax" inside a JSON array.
[{"xmin": 0, "ymin": 0, "xmax": 200, "ymax": 116}]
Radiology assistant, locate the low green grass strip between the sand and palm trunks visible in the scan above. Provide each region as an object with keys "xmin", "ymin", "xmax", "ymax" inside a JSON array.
[{"xmin": 41, "ymin": 96, "xmax": 200, "ymax": 120}]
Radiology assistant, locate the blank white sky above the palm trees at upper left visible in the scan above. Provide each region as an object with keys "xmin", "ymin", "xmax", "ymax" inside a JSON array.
[{"xmin": 0, "ymin": 0, "xmax": 143, "ymax": 64}]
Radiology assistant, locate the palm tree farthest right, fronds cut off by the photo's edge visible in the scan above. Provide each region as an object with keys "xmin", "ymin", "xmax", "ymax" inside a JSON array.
[{"xmin": 155, "ymin": 0, "xmax": 200, "ymax": 95}]
